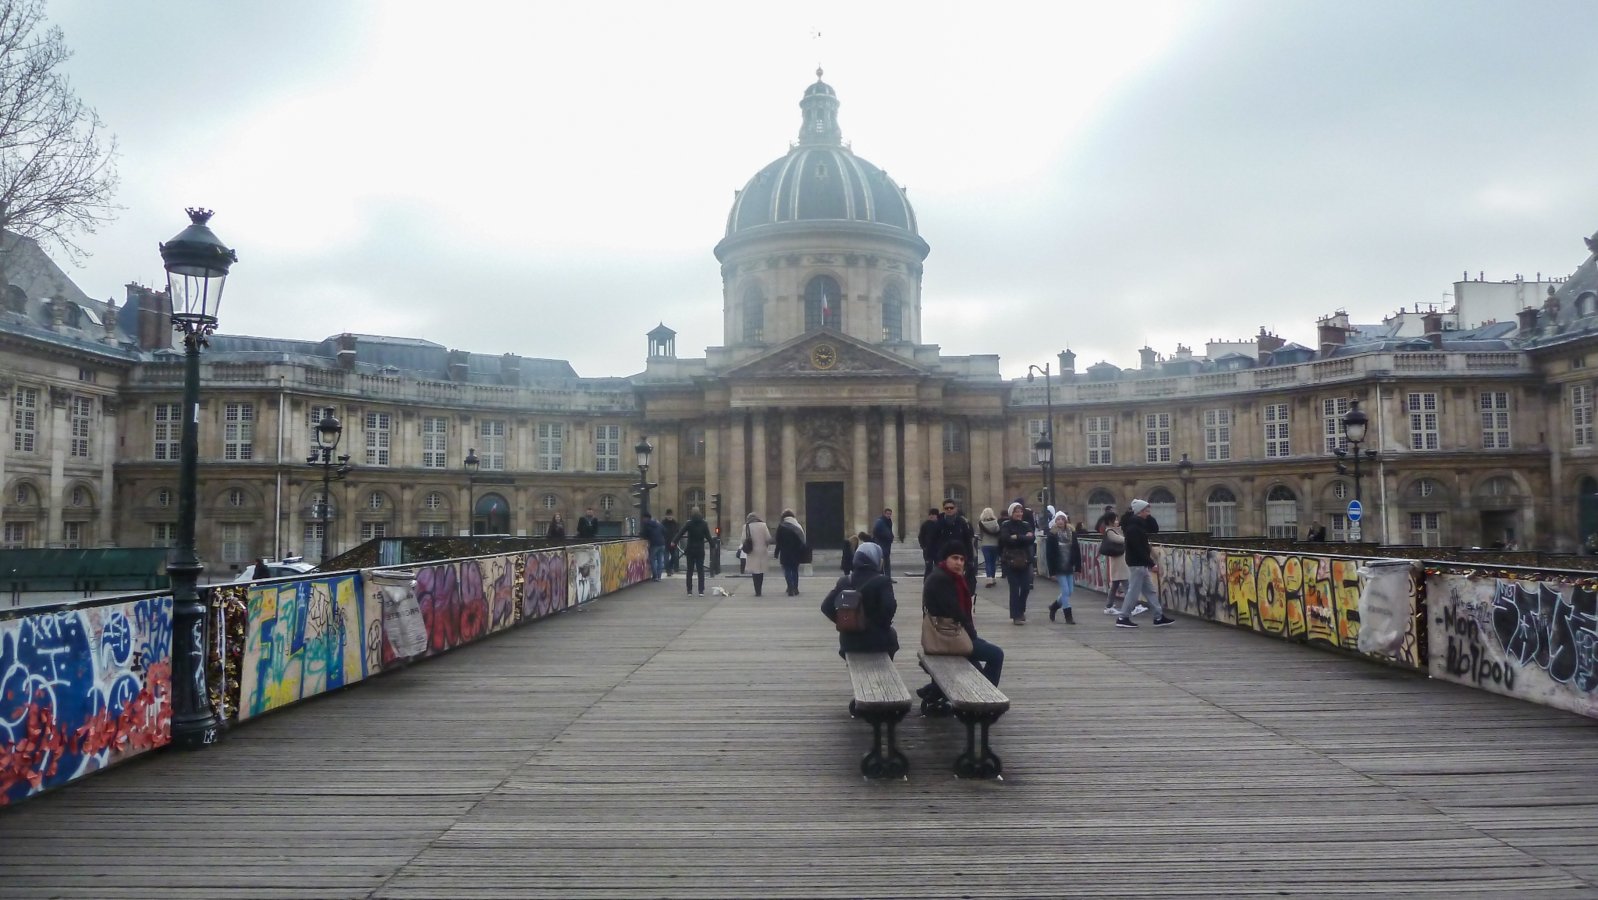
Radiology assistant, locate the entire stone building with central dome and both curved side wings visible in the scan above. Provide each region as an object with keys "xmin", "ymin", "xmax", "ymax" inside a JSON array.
[{"xmin": 0, "ymin": 78, "xmax": 1598, "ymax": 571}]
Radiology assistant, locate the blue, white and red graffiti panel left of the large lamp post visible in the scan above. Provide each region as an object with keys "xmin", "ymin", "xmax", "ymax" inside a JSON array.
[{"xmin": 0, "ymin": 596, "xmax": 173, "ymax": 806}]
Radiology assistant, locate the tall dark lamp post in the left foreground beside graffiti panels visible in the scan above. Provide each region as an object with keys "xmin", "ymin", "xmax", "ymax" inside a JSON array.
[{"xmin": 160, "ymin": 209, "xmax": 238, "ymax": 750}]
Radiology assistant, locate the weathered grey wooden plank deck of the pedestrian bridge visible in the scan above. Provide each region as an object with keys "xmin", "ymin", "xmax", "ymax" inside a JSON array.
[{"xmin": 0, "ymin": 577, "xmax": 1598, "ymax": 900}]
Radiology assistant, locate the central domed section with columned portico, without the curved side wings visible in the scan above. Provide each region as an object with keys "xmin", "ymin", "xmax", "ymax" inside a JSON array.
[{"xmin": 634, "ymin": 70, "xmax": 1007, "ymax": 547}]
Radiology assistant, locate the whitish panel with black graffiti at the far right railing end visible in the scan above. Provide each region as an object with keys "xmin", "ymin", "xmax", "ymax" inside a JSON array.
[{"xmin": 1427, "ymin": 575, "xmax": 1598, "ymax": 718}]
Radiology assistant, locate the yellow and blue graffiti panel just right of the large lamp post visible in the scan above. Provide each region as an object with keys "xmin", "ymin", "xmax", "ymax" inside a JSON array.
[{"xmin": 238, "ymin": 575, "xmax": 377, "ymax": 719}]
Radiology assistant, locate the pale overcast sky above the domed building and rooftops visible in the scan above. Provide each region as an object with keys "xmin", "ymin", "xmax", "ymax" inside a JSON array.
[{"xmin": 48, "ymin": 0, "xmax": 1598, "ymax": 376}]
